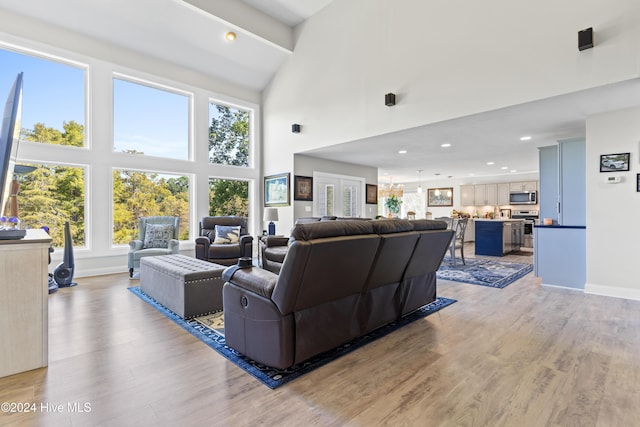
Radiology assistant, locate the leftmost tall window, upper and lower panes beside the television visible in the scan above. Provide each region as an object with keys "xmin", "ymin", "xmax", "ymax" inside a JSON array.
[{"xmin": 0, "ymin": 49, "xmax": 87, "ymax": 247}]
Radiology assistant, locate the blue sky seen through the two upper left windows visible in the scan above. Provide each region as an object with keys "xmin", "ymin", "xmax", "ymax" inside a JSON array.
[{"xmin": 0, "ymin": 49, "xmax": 189, "ymax": 160}]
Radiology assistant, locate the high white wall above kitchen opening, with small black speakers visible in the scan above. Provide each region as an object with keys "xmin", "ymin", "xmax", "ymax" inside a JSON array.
[{"xmin": 263, "ymin": 0, "xmax": 640, "ymax": 232}]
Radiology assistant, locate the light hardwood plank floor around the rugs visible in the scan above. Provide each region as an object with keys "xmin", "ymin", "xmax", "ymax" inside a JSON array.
[{"xmin": 0, "ymin": 248, "xmax": 640, "ymax": 427}]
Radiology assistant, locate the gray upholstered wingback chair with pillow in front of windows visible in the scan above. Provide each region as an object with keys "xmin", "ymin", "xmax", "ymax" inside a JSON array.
[{"xmin": 129, "ymin": 216, "xmax": 180, "ymax": 277}]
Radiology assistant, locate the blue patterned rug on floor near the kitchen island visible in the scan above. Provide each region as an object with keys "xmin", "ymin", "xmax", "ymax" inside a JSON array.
[{"xmin": 436, "ymin": 257, "xmax": 533, "ymax": 288}]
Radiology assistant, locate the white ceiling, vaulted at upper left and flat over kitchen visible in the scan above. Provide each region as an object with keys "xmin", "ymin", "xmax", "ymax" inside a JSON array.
[{"xmin": 0, "ymin": 0, "xmax": 640, "ymax": 182}]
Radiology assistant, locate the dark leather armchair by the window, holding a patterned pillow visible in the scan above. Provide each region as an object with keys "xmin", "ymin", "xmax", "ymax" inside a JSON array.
[{"xmin": 196, "ymin": 216, "xmax": 253, "ymax": 265}]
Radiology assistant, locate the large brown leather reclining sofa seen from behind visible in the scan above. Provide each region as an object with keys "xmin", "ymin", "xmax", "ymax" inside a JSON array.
[{"xmin": 223, "ymin": 219, "xmax": 453, "ymax": 369}]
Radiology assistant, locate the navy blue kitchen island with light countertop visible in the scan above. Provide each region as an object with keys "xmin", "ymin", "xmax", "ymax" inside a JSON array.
[{"xmin": 474, "ymin": 218, "xmax": 524, "ymax": 256}]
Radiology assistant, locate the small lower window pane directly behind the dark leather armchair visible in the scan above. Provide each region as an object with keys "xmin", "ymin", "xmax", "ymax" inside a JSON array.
[{"xmin": 209, "ymin": 178, "xmax": 249, "ymax": 218}]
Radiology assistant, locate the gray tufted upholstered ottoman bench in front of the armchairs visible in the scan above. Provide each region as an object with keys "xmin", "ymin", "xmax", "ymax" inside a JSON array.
[{"xmin": 140, "ymin": 255, "xmax": 227, "ymax": 319}]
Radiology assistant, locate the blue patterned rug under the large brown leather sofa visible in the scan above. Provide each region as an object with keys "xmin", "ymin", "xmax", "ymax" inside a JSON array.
[{"xmin": 129, "ymin": 286, "xmax": 456, "ymax": 389}]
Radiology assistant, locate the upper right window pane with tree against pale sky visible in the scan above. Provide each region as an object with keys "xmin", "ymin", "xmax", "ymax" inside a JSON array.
[{"xmin": 209, "ymin": 103, "xmax": 251, "ymax": 166}]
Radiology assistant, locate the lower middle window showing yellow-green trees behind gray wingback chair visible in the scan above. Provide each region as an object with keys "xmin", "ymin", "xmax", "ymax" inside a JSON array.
[{"xmin": 113, "ymin": 170, "xmax": 189, "ymax": 244}]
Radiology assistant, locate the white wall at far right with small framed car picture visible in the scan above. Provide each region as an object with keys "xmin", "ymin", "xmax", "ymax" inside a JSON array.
[{"xmin": 585, "ymin": 108, "xmax": 640, "ymax": 300}]
